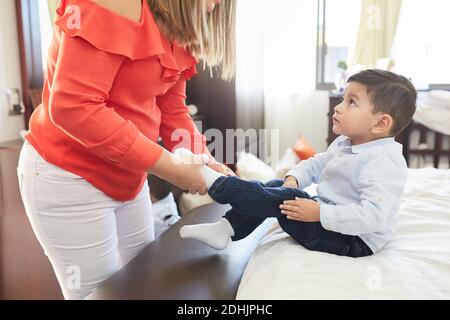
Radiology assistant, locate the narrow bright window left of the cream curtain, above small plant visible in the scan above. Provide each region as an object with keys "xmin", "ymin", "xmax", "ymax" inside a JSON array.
[{"xmin": 316, "ymin": 0, "xmax": 362, "ymax": 90}]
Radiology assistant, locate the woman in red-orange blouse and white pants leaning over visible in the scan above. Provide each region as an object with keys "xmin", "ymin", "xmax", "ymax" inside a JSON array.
[{"xmin": 17, "ymin": 0, "xmax": 235, "ymax": 299}]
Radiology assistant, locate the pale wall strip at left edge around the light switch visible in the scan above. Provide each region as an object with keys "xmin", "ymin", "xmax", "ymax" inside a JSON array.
[{"xmin": 0, "ymin": 0, "xmax": 24, "ymax": 142}]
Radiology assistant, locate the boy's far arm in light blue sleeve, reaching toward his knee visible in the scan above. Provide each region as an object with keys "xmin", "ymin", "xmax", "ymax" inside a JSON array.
[{"xmin": 285, "ymin": 152, "xmax": 326, "ymax": 188}]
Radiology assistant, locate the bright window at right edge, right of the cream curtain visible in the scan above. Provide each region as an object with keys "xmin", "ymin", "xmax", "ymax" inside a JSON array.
[{"xmin": 392, "ymin": 0, "xmax": 450, "ymax": 89}]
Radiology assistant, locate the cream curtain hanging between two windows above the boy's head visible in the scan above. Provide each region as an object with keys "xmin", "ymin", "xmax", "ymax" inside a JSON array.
[{"xmin": 351, "ymin": 0, "xmax": 402, "ymax": 68}]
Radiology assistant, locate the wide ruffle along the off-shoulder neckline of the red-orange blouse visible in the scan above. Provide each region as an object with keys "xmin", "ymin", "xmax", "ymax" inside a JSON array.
[{"xmin": 55, "ymin": 0, "xmax": 198, "ymax": 82}]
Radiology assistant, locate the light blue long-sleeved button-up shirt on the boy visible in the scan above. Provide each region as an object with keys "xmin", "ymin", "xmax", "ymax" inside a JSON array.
[{"xmin": 286, "ymin": 136, "xmax": 408, "ymax": 253}]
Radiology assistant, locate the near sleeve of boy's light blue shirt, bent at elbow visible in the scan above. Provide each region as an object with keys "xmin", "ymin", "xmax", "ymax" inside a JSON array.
[{"xmin": 320, "ymin": 157, "xmax": 408, "ymax": 235}]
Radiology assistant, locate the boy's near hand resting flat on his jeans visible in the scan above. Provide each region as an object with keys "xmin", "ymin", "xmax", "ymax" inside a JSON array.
[{"xmin": 280, "ymin": 197, "xmax": 320, "ymax": 222}]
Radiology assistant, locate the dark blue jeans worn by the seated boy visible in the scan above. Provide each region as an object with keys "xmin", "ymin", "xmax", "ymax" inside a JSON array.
[{"xmin": 208, "ymin": 177, "xmax": 373, "ymax": 258}]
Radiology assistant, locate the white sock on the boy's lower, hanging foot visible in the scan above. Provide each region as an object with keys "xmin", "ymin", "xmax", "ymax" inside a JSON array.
[{"xmin": 180, "ymin": 218, "xmax": 234, "ymax": 250}]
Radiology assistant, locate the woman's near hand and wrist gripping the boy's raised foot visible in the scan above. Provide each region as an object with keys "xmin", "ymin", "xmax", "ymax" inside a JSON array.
[{"xmin": 147, "ymin": 150, "xmax": 208, "ymax": 195}]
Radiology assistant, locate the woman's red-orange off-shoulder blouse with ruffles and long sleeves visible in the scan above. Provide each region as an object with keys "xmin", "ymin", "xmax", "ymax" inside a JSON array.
[{"xmin": 26, "ymin": 0, "xmax": 209, "ymax": 201}]
